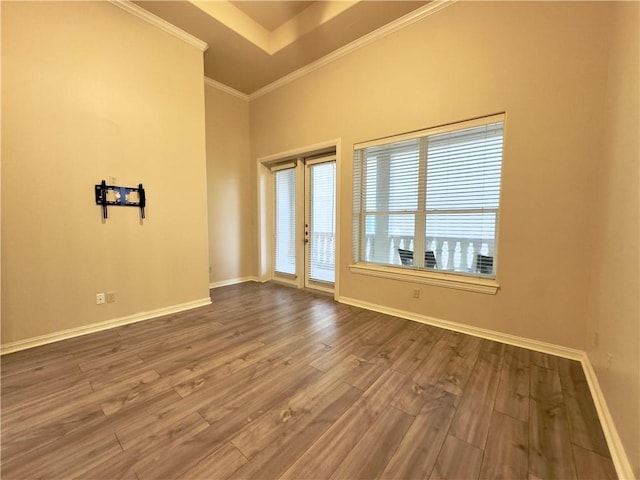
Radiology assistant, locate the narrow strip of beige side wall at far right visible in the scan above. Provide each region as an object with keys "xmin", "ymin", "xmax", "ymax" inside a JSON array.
[{"xmin": 589, "ymin": 2, "xmax": 640, "ymax": 478}]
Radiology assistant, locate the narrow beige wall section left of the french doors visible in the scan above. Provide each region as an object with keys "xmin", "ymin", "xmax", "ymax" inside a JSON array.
[{"xmin": 205, "ymin": 85, "xmax": 256, "ymax": 284}]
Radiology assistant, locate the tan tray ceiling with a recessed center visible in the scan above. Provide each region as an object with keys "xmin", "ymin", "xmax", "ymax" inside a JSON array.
[{"xmin": 134, "ymin": 0, "xmax": 429, "ymax": 95}]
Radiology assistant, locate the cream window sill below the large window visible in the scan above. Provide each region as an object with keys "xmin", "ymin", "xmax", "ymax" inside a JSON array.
[{"xmin": 349, "ymin": 263, "xmax": 500, "ymax": 295}]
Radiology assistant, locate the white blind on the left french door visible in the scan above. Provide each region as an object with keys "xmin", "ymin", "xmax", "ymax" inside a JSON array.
[{"xmin": 273, "ymin": 167, "xmax": 296, "ymax": 275}]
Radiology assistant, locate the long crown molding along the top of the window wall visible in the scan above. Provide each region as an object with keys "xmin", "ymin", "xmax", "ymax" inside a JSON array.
[{"xmin": 249, "ymin": 0, "xmax": 458, "ymax": 100}]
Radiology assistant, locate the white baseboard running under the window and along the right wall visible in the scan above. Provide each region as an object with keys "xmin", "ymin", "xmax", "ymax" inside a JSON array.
[{"xmin": 337, "ymin": 297, "xmax": 635, "ymax": 480}]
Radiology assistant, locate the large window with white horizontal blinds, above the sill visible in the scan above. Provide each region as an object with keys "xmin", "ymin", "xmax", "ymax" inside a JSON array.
[{"xmin": 353, "ymin": 115, "xmax": 504, "ymax": 279}]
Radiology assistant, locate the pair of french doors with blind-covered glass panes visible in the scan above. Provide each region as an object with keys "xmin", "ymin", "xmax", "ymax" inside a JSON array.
[{"xmin": 273, "ymin": 155, "xmax": 336, "ymax": 291}]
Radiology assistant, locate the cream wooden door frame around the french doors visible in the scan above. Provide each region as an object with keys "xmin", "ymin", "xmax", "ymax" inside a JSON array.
[{"xmin": 256, "ymin": 138, "xmax": 342, "ymax": 299}]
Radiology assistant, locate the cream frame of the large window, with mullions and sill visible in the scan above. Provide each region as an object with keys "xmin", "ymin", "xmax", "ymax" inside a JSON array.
[{"xmin": 349, "ymin": 113, "xmax": 506, "ymax": 295}]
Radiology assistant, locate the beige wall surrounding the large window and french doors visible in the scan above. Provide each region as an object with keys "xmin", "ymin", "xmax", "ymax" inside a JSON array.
[{"xmin": 251, "ymin": 2, "xmax": 609, "ymax": 348}]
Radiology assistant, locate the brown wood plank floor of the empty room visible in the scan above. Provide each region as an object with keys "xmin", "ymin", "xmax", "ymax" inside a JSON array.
[{"xmin": 0, "ymin": 283, "xmax": 616, "ymax": 480}]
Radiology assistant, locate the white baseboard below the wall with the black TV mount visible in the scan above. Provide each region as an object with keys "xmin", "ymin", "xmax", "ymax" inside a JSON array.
[{"xmin": 0, "ymin": 297, "xmax": 211, "ymax": 355}]
